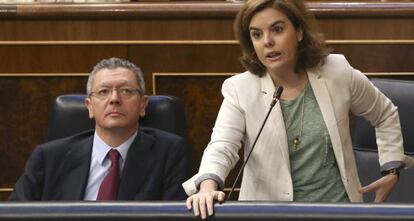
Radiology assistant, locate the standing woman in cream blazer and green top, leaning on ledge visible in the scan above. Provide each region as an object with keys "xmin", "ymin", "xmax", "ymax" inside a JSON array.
[{"xmin": 183, "ymin": 0, "xmax": 412, "ymax": 218}]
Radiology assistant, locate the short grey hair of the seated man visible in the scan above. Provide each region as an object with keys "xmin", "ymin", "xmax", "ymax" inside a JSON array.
[{"xmin": 86, "ymin": 57, "xmax": 145, "ymax": 94}]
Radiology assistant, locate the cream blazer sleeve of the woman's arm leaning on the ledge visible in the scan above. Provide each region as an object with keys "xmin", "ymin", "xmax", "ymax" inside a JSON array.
[{"xmin": 183, "ymin": 78, "xmax": 245, "ymax": 195}]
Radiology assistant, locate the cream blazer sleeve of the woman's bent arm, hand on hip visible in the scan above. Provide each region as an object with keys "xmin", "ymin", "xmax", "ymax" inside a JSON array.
[{"xmin": 350, "ymin": 67, "xmax": 412, "ymax": 170}]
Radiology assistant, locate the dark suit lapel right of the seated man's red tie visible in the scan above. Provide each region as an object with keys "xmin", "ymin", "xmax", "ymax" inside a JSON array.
[{"xmin": 118, "ymin": 130, "xmax": 155, "ymax": 200}]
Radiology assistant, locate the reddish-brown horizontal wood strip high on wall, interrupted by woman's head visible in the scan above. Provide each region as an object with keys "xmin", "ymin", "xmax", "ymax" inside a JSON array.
[{"xmin": 0, "ymin": 17, "xmax": 414, "ymax": 41}]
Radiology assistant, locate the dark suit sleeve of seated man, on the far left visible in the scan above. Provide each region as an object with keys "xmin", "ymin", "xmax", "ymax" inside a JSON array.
[{"xmin": 9, "ymin": 147, "xmax": 45, "ymax": 201}]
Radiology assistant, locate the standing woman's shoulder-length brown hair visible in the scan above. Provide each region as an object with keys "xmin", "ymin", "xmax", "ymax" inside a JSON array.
[{"xmin": 234, "ymin": 0, "xmax": 330, "ymax": 76}]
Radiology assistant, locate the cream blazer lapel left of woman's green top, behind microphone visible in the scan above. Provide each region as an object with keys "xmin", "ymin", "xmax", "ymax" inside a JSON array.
[{"xmin": 260, "ymin": 74, "xmax": 290, "ymax": 165}]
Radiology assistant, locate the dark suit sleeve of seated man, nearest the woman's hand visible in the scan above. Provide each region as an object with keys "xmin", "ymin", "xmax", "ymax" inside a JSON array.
[{"xmin": 162, "ymin": 137, "xmax": 189, "ymax": 200}]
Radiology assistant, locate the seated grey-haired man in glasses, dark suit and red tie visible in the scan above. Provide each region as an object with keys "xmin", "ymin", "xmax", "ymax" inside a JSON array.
[{"xmin": 9, "ymin": 58, "xmax": 187, "ymax": 200}]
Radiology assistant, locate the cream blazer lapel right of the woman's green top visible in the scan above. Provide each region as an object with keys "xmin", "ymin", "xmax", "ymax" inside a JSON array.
[{"xmin": 308, "ymin": 71, "xmax": 346, "ymax": 175}]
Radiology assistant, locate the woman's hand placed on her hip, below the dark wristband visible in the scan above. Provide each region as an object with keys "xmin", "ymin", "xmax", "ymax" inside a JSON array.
[{"xmin": 359, "ymin": 173, "xmax": 398, "ymax": 203}]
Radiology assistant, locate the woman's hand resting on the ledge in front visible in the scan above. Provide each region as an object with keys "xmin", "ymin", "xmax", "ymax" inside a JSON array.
[{"xmin": 186, "ymin": 180, "xmax": 226, "ymax": 219}]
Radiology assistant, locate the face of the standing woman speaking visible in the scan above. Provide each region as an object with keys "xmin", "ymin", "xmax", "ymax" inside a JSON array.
[{"xmin": 249, "ymin": 8, "xmax": 303, "ymax": 74}]
